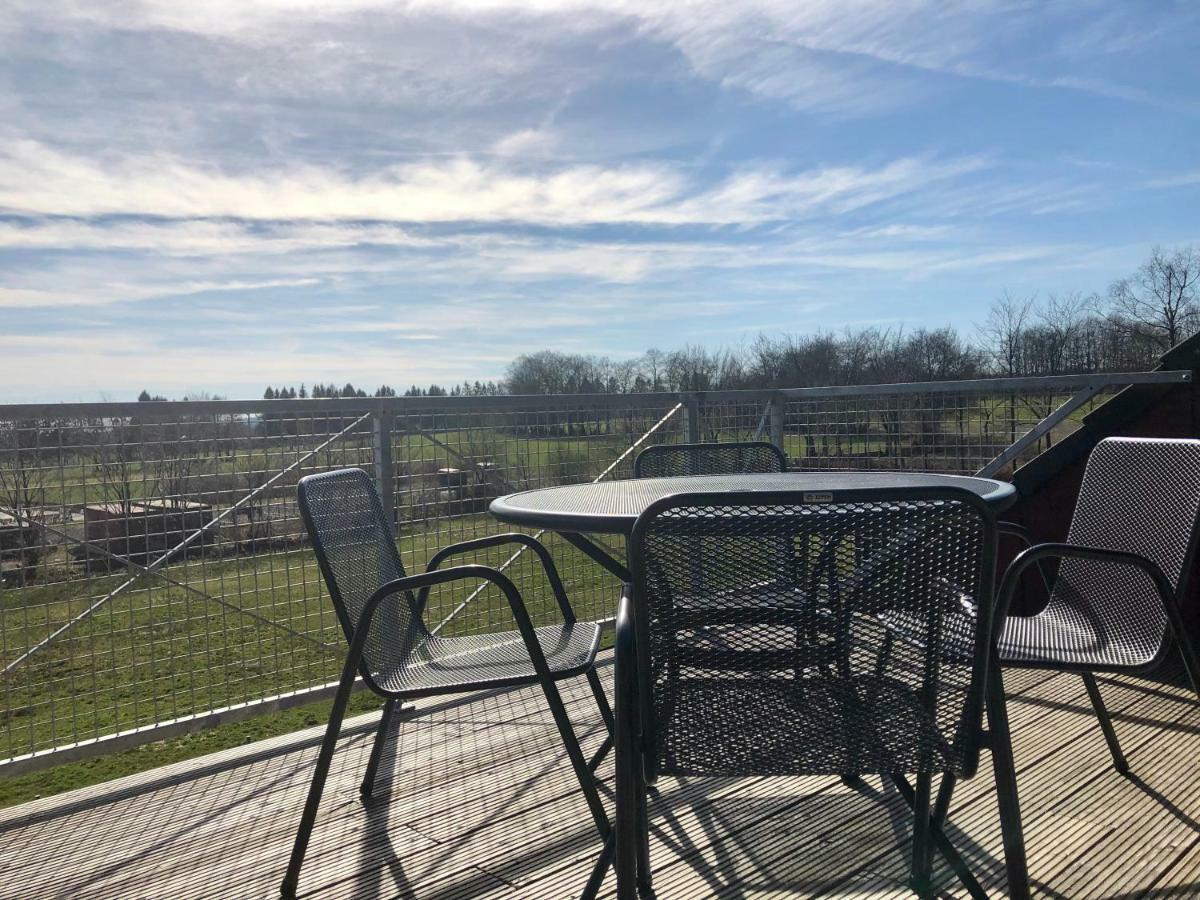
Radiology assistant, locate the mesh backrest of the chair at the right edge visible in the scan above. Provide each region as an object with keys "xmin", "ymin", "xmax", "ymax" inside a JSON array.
[{"xmin": 1050, "ymin": 438, "xmax": 1200, "ymax": 650}]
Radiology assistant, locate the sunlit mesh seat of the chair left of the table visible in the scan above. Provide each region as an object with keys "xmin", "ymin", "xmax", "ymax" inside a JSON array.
[{"xmin": 374, "ymin": 622, "xmax": 600, "ymax": 696}]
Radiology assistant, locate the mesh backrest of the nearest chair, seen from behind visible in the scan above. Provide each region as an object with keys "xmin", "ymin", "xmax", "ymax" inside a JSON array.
[{"xmin": 630, "ymin": 488, "xmax": 996, "ymax": 775}]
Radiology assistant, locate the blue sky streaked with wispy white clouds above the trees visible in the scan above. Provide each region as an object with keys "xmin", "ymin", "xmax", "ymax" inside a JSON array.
[{"xmin": 0, "ymin": 0, "xmax": 1200, "ymax": 402}]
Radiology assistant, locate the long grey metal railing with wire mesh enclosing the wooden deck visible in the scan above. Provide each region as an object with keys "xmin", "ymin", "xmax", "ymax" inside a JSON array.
[{"xmin": 0, "ymin": 372, "xmax": 1190, "ymax": 773}]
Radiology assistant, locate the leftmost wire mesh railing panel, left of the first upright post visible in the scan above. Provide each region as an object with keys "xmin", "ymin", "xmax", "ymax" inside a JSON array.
[{"xmin": 0, "ymin": 404, "xmax": 371, "ymax": 758}]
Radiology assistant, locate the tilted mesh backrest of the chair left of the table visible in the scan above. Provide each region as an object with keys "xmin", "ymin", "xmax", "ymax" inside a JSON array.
[{"xmin": 296, "ymin": 469, "xmax": 426, "ymax": 678}]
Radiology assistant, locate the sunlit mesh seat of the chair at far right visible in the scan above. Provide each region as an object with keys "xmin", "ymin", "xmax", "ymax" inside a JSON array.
[{"xmin": 998, "ymin": 602, "xmax": 1164, "ymax": 668}]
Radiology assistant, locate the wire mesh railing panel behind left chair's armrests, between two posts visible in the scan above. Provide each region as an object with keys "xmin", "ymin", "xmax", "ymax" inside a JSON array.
[{"xmin": 392, "ymin": 395, "xmax": 680, "ymax": 634}]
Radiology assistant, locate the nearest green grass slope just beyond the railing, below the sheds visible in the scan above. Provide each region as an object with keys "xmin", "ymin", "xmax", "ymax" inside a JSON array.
[{"xmin": 0, "ymin": 515, "xmax": 619, "ymax": 802}]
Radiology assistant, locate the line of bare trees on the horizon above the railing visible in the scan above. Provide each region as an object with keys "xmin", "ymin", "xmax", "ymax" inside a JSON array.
[{"xmin": 139, "ymin": 246, "xmax": 1200, "ymax": 400}]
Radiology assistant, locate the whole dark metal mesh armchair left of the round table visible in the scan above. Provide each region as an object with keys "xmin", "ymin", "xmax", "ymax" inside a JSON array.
[{"xmin": 282, "ymin": 469, "xmax": 612, "ymax": 896}]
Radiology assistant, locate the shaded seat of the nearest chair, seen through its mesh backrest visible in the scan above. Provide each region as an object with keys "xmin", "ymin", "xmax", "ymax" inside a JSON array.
[{"xmin": 659, "ymin": 674, "xmax": 960, "ymax": 775}]
